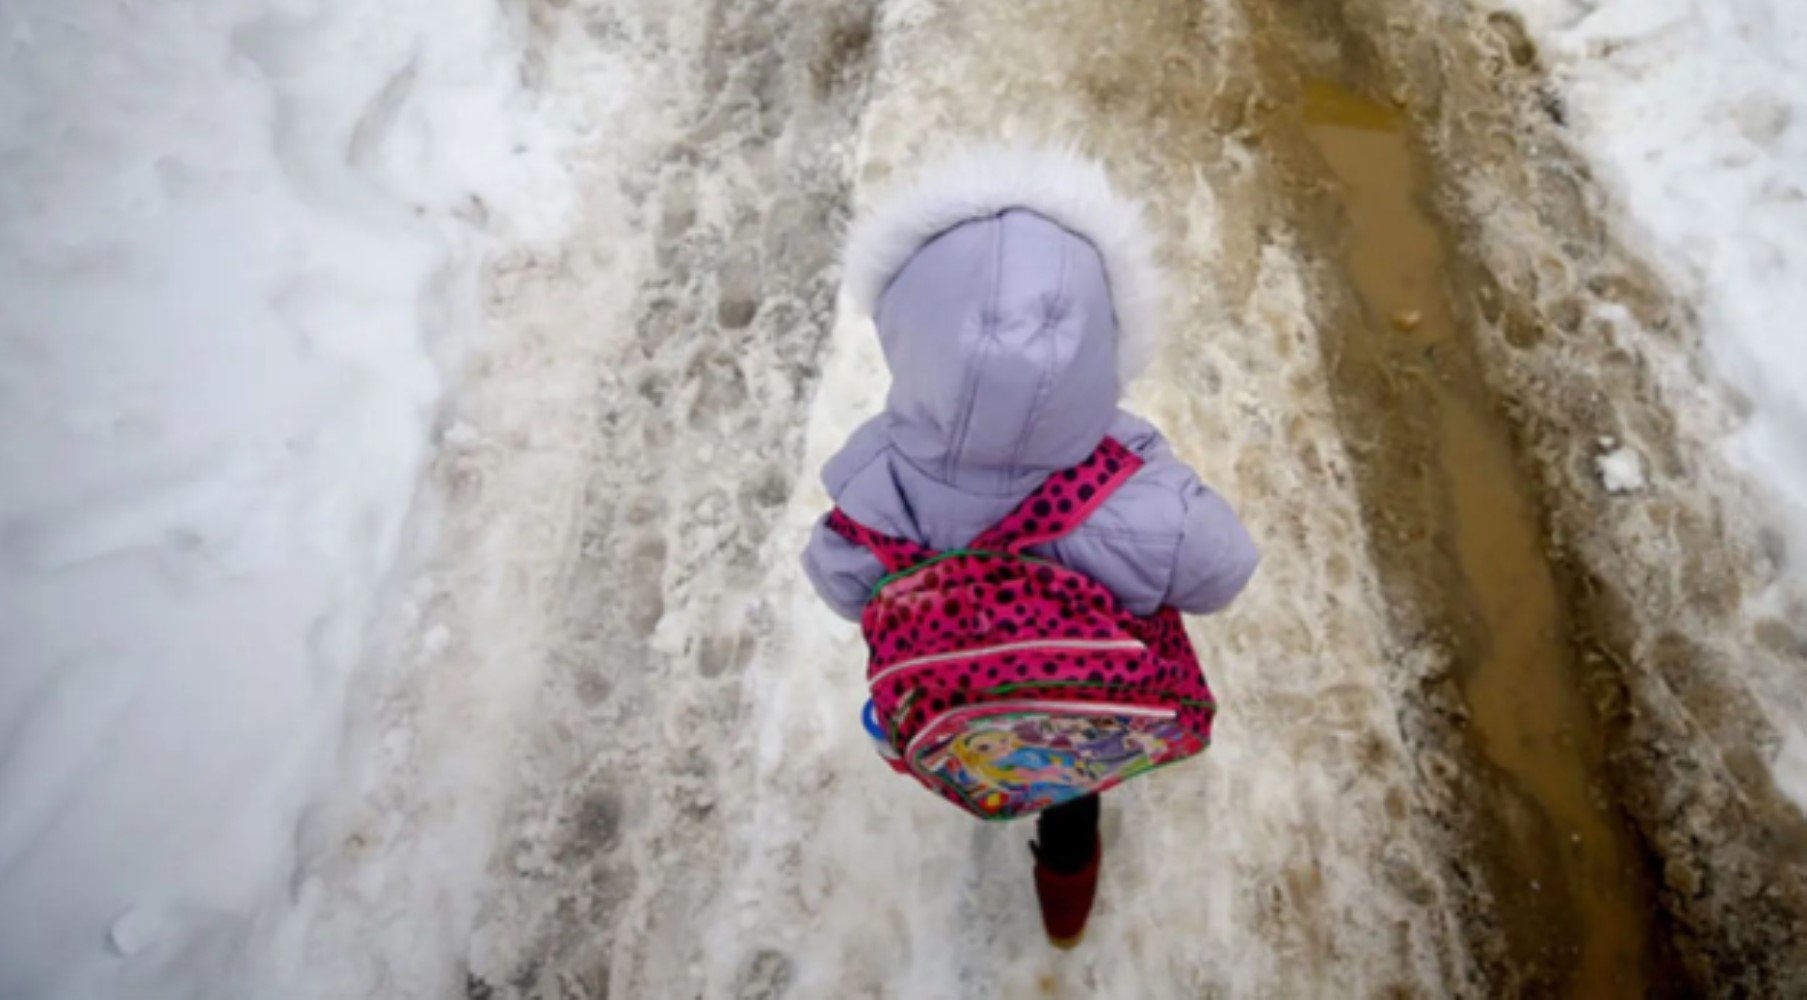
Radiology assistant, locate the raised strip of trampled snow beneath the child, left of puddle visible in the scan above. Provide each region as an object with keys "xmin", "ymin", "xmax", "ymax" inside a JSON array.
[{"xmin": 636, "ymin": 5, "xmax": 1460, "ymax": 996}]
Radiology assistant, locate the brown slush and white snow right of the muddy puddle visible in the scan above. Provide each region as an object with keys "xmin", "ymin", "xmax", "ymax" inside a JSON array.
[{"xmin": 1341, "ymin": 0, "xmax": 1807, "ymax": 995}]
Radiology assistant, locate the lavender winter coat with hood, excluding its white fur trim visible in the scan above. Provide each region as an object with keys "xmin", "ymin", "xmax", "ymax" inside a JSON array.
[{"xmin": 804, "ymin": 178, "xmax": 1258, "ymax": 618}]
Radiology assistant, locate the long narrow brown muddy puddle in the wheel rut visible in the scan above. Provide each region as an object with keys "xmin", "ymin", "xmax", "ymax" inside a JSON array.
[{"xmin": 1303, "ymin": 81, "xmax": 1659, "ymax": 996}]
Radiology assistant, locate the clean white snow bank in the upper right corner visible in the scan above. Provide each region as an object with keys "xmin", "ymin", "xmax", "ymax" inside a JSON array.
[{"xmin": 1509, "ymin": 0, "xmax": 1807, "ymax": 577}]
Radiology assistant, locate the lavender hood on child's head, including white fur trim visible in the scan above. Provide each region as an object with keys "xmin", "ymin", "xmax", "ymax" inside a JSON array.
[{"xmin": 846, "ymin": 150, "xmax": 1156, "ymax": 494}]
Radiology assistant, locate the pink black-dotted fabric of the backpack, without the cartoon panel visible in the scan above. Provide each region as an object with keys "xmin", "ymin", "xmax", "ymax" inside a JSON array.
[{"xmin": 828, "ymin": 432, "xmax": 1216, "ymax": 816}]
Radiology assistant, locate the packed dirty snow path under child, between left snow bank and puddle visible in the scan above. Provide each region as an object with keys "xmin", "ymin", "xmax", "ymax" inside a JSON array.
[{"xmin": 292, "ymin": 0, "xmax": 1807, "ymax": 996}]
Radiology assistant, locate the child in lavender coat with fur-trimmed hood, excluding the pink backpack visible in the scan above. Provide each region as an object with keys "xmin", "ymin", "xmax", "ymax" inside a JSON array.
[{"xmin": 804, "ymin": 141, "xmax": 1258, "ymax": 944}]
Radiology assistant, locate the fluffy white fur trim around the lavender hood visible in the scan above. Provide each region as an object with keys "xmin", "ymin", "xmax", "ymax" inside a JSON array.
[{"xmin": 842, "ymin": 146, "xmax": 1160, "ymax": 385}]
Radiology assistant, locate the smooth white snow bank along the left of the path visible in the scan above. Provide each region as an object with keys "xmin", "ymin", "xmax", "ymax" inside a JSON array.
[{"xmin": 0, "ymin": 0, "xmax": 569, "ymax": 998}]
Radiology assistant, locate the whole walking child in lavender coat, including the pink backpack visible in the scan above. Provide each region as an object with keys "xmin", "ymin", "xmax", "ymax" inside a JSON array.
[{"xmin": 804, "ymin": 148, "xmax": 1258, "ymax": 946}]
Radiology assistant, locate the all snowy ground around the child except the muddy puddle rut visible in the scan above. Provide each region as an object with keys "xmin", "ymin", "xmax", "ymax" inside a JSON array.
[{"xmin": 0, "ymin": 0, "xmax": 1807, "ymax": 998}]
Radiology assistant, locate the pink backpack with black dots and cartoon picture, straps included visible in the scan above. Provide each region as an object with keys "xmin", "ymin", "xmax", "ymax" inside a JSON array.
[{"xmin": 828, "ymin": 438, "xmax": 1216, "ymax": 819}]
